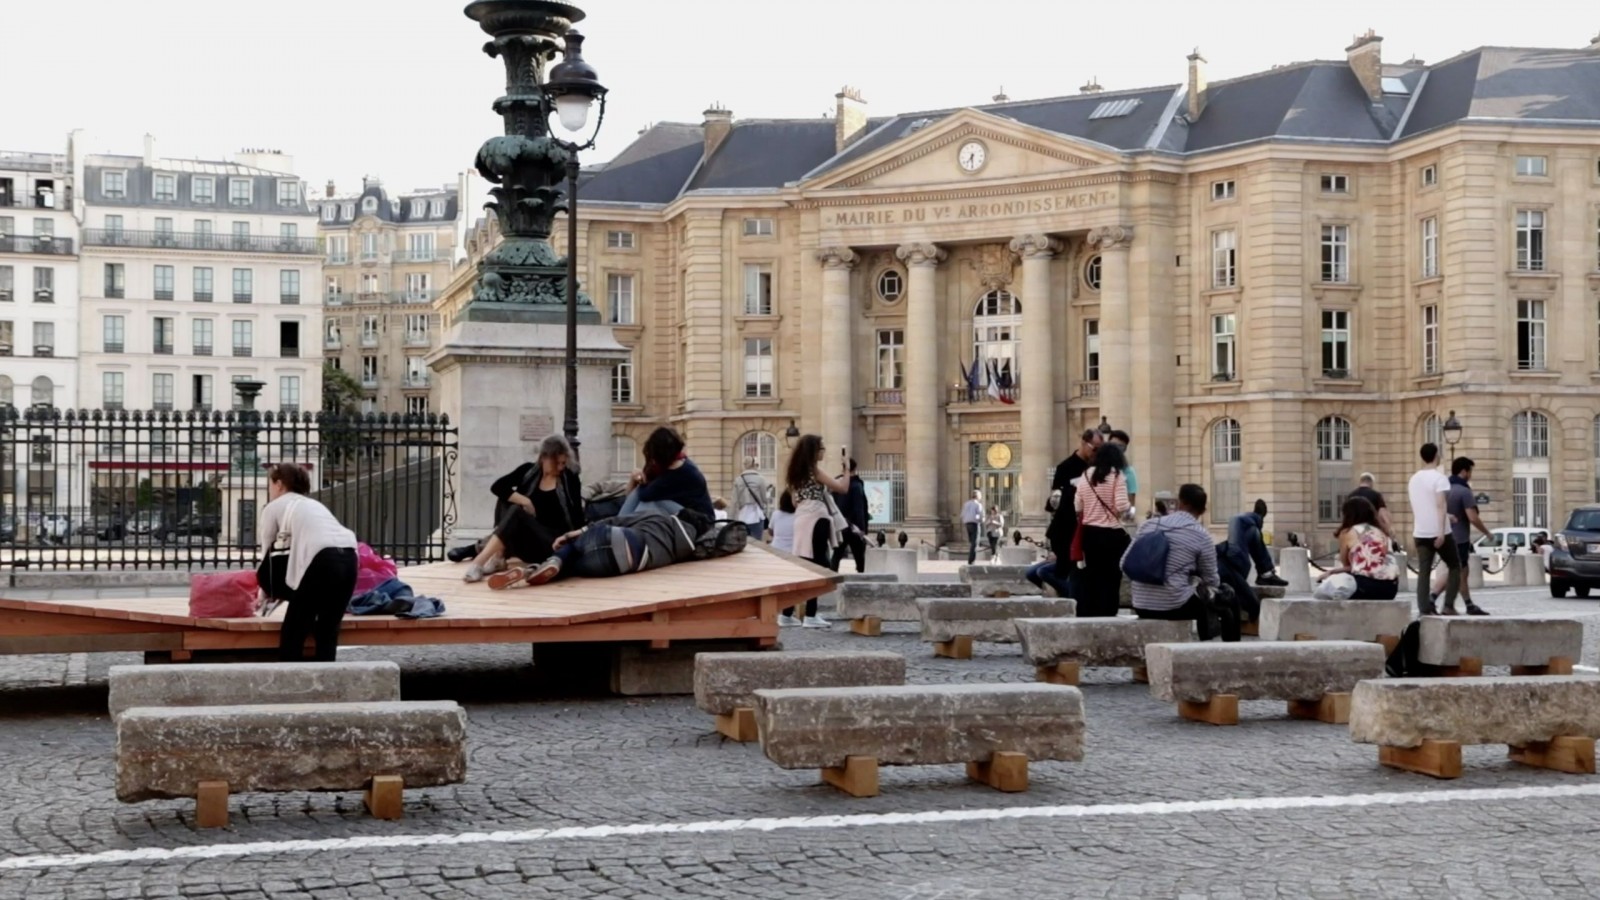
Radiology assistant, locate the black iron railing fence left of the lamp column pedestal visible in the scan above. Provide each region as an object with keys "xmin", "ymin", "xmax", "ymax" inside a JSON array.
[{"xmin": 0, "ymin": 400, "xmax": 458, "ymax": 570}]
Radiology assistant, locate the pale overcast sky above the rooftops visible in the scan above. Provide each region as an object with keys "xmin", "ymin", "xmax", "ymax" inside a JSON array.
[{"xmin": 0, "ymin": 0, "xmax": 1600, "ymax": 192}]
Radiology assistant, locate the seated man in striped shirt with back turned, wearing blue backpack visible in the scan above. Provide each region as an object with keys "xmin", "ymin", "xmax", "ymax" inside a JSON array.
[{"xmin": 1133, "ymin": 484, "xmax": 1238, "ymax": 641}]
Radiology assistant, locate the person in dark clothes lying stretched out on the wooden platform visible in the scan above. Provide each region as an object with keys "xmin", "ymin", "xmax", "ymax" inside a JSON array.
[{"xmin": 490, "ymin": 509, "xmax": 712, "ymax": 589}]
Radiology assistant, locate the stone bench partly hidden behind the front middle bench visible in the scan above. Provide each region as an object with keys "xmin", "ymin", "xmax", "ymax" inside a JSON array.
[{"xmin": 694, "ymin": 650, "xmax": 906, "ymax": 741}]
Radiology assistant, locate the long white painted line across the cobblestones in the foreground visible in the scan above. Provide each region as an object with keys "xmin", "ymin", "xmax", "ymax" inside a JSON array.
[{"xmin": 0, "ymin": 785, "xmax": 1600, "ymax": 870}]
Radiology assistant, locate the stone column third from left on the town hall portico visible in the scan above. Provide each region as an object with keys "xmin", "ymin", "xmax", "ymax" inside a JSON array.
[{"xmin": 1011, "ymin": 234, "xmax": 1061, "ymax": 530}]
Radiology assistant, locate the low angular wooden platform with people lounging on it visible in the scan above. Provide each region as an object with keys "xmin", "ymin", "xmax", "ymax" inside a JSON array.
[{"xmin": 0, "ymin": 544, "xmax": 838, "ymax": 660}]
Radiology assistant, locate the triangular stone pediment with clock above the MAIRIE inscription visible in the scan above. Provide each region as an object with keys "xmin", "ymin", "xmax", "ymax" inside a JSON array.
[{"xmin": 805, "ymin": 109, "xmax": 1125, "ymax": 191}]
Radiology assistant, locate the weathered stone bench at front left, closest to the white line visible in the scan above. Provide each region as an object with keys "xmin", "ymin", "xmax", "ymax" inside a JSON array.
[{"xmin": 117, "ymin": 700, "xmax": 467, "ymax": 828}]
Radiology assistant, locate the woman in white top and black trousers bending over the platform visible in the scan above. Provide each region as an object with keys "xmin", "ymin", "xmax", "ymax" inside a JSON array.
[{"xmin": 258, "ymin": 463, "xmax": 357, "ymax": 663}]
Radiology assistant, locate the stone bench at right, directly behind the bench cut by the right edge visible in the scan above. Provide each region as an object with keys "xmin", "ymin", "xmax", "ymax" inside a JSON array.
[{"xmin": 1416, "ymin": 615, "xmax": 1584, "ymax": 677}]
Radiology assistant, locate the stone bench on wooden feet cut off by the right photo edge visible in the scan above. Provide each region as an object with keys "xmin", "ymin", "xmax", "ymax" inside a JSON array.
[{"xmin": 1350, "ymin": 676, "xmax": 1600, "ymax": 778}]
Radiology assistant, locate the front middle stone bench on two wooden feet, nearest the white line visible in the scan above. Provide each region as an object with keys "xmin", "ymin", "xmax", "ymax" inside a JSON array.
[{"xmin": 755, "ymin": 684, "xmax": 1083, "ymax": 798}]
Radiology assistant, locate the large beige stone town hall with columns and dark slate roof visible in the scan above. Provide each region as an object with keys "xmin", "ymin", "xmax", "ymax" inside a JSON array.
[{"xmin": 440, "ymin": 32, "xmax": 1600, "ymax": 540}]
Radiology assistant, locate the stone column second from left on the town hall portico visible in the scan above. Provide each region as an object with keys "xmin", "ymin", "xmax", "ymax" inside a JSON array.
[{"xmin": 894, "ymin": 243, "xmax": 946, "ymax": 543}]
